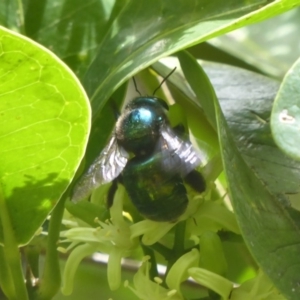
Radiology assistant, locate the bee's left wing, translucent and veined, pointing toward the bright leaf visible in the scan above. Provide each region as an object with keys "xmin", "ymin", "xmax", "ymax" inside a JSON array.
[{"xmin": 72, "ymin": 136, "xmax": 128, "ymax": 202}]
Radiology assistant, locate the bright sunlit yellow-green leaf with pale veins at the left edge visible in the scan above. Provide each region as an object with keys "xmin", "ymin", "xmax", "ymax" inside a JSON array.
[{"xmin": 0, "ymin": 28, "xmax": 90, "ymax": 244}]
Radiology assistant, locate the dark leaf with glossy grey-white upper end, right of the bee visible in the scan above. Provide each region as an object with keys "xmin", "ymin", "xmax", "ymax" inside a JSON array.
[{"xmin": 208, "ymin": 66, "xmax": 300, "ymax": 196}]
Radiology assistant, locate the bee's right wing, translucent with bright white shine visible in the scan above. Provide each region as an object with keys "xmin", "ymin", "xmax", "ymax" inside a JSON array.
[{"xmin": 160, "ymin": 124, "xmax": 202, "ymax": 176}]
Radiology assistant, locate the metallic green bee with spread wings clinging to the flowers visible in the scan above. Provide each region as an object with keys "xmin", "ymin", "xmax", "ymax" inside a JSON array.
[{"xmin": 73, "ymin": 76, "xmax": 205, "ymax": 221}]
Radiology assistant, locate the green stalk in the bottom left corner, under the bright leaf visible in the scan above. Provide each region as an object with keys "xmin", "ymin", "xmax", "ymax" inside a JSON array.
[{"xmin": 0, "ymin": 185, "xmax": 28, "ymax": 300}]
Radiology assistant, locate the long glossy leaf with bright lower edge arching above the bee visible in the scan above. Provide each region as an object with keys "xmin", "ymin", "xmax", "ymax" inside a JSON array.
[{"xmin": 84, "ymin": 0, "xmax": 288, "ymax": 117}]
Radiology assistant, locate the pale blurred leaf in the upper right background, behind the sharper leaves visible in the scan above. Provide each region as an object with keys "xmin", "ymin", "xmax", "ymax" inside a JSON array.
[{"xmin": 209, "ymin": 8, "xmax": 300, "ymax": 79}]
